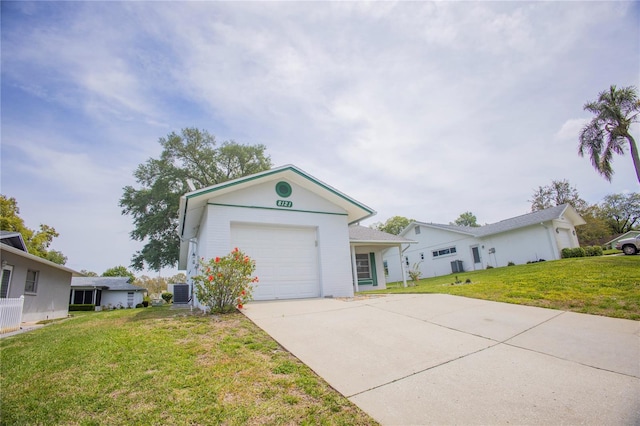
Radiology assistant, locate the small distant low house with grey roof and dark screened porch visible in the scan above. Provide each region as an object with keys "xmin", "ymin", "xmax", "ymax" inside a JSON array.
[{"xmin": 68, "ymin": 277, "xmax": 147, "ymax": 309}]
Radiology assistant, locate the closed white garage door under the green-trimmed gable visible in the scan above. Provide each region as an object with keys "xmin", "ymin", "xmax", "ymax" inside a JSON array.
[{"xmin": 231, "ymin": 224, "xmax": 320, "ymax": 300}]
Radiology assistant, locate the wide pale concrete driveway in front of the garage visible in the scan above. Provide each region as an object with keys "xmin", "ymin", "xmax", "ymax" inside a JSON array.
[{"xmin": 244, "ymin": 294, "xmax": 640, "ymax": 425}]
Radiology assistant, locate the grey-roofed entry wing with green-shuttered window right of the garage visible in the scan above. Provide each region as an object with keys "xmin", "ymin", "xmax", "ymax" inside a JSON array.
[{"xmin": 349, "ymin": 225, "xmax": 417, "ymax": 291}]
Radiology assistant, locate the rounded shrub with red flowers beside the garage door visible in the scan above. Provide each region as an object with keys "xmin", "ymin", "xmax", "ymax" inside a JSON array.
[{"xmin": 192, "ymin": 247, "xmax": 258, "ymax": 313}]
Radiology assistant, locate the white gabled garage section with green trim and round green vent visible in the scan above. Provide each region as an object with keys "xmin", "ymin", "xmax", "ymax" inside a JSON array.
[{"xmin": 178, "ymin": 165, "xmax": 390, "ymax": 307}]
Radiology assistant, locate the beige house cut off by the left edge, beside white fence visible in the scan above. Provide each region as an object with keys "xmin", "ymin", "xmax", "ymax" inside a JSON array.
[{"xmin": 0, "ymin": 231, "xmax": 80, "ymax": 322}]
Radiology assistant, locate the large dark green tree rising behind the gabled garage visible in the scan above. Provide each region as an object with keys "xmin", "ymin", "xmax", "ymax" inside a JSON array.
[{"xmin": 120, "ymin": 128, "xmax": 271, "ymax": 271}]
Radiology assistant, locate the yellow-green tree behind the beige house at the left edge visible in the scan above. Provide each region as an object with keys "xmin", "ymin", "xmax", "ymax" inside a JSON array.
[{"xmin": 0, "ymin": 195, "xmax": 67, "ymax": 265}]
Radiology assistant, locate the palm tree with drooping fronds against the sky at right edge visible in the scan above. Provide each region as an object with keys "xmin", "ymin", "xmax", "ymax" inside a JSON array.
[{"xmin": 578, "ymin": 86, "xmax": 640, "ymax": 182}]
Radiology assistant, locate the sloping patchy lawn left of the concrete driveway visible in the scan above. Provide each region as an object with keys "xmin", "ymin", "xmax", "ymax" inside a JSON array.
[{"xmin": 0, "ymin": 307, "xmax": 375, "ymax": 425}]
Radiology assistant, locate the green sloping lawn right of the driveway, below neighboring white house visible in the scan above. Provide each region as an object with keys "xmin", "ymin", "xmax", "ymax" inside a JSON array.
[{"xmin": 366, "ymin": 256, "xmax": 640, "ymax": 320}]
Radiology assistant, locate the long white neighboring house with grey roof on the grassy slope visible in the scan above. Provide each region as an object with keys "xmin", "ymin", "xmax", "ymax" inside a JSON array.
[{"xmin": 383, "ymin": 204, "xmax": 586, "ymax": 282}]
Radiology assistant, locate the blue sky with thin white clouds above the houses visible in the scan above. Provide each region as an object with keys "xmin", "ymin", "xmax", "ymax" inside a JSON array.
[{"xmin": 1, "ymin": 1, "xmax": 640, "ymax": 275}]
